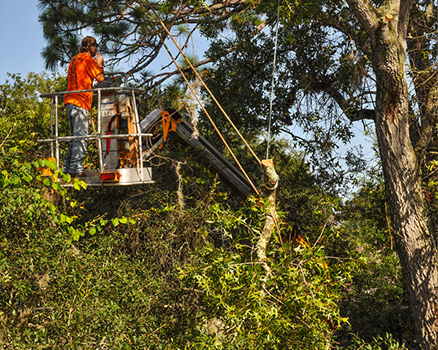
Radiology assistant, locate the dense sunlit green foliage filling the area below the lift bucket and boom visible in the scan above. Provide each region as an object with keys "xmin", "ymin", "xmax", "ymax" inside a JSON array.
[{"xmin": 0, "ymin": 73, "xmax": 415, "ymax": 349}]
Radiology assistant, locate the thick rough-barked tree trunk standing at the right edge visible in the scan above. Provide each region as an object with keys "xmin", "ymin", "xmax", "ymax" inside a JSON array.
[{"xmin": 373, "ymin": 14, "xmax": 438, "ymax": 350}]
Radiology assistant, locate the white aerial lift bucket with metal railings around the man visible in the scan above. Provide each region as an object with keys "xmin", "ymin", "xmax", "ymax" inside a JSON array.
[{"xmin": 39, "ymin": 73, "xmax": 154, "ymax": 186}]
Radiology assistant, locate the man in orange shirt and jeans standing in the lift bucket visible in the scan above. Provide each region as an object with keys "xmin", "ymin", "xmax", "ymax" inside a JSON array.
[{"xmin": 63, "ymin": 36, "xmax": 105, "ymax": 177}]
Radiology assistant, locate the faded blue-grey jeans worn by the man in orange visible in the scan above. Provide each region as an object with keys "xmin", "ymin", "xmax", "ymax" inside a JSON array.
[{"xmin": 63, "ymin": 103, "xmax": 90, "ymax": 173}]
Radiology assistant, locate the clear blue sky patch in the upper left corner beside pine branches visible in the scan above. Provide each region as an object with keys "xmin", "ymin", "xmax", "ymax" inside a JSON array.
[{"xmin": 0, "ymin": 0, "xmax": 46, "ymax": 84}]
